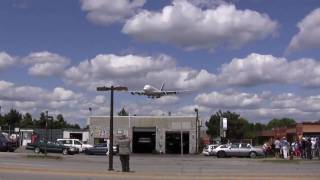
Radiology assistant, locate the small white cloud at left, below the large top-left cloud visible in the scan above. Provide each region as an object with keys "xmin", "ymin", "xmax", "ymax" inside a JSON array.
[{"xmin": 22, "ymin": 51, "xmax": 70, "ymax": 76}]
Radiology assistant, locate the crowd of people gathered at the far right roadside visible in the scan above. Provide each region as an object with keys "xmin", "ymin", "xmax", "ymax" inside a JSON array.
[{"xmin": 263, "ymin": 137, "xmax": 320, "ymax": 159}]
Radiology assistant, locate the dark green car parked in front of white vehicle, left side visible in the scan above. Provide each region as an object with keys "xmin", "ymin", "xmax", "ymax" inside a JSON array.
[{"xmin": 33, "ymin": 140, "xmax": 79, "ymax": 155}]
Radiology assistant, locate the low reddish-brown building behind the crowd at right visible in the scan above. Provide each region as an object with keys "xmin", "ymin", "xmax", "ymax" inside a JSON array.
[{"xmin": 257, "ymin": 122, "xmax": 320, "ymax": 141}]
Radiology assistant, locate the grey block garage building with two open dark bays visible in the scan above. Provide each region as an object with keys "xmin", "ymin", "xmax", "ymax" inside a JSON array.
[{"xmin": 89, "ymin": 116, "xmax": 198, "ymax": 154}]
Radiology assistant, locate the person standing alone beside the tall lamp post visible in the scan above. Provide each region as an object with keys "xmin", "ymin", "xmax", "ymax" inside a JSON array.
[{"xmin": 118, "ymin": 135, "xmax": 130, "ymax": 172}]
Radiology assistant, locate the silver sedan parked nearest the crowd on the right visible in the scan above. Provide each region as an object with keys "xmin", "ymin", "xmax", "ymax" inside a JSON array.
[{"xmin": 213, "ymin": 143, "xmax": 264, "ymax": 158}]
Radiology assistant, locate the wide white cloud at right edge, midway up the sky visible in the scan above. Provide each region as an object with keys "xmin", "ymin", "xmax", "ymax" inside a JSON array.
[{"xmin": 217, "ymin": 54, "xmax": 320, "ymax": 87}]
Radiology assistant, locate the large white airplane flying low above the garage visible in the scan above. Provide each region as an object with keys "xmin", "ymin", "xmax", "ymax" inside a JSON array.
[{"xmin": 130, "ymin": 83, "xmax": 187, "ymax": 99}]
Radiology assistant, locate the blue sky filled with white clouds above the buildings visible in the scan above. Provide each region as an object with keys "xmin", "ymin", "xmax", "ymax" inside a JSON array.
[{"xmin": 0, "ymin": 0, "xmax": 320, "ymax": 126}]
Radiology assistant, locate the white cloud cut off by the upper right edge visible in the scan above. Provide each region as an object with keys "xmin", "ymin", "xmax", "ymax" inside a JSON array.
[{"xmin": 287, "ymin": 8, "xmax": 320, "ymax": 52}]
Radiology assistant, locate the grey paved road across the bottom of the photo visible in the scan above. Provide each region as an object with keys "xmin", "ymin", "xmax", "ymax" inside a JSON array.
[{"xmin": 0, "ymin": 153, "xmax": 320, "ymax": 180}]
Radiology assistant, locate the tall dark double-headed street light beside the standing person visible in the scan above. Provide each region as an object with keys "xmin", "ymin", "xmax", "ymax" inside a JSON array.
[{"xmin": 97, "ymin": 86, "xmax": 128, "ymax": 171}]
